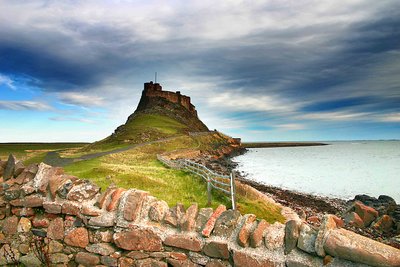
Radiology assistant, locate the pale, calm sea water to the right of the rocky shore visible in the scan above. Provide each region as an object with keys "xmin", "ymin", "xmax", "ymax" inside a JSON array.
[{"xmin": 234, "ymin": 141, "xmax": 400, "ymax": 203}]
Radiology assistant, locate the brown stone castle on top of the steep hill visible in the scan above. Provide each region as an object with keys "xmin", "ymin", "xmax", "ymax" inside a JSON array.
[{"xmin": 142, "ymin": 81, "xmax": 197, "ymax": 117}]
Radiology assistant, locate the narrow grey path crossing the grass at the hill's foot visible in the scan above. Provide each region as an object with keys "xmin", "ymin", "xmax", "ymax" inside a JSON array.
[{"xmin": 43, "ymin": 136, "xmax": 180, "ymax": 167}]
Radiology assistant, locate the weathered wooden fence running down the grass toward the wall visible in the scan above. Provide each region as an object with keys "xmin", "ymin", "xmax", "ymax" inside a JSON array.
[{"xmin": 157, "ymin": 155, "xmax": 236, "ymax": 210}]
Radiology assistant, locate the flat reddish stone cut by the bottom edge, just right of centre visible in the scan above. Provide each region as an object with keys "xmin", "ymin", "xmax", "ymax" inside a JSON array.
[{"xmin": 233, "ymin": 251, "xmax": 285, "ymax": 267}]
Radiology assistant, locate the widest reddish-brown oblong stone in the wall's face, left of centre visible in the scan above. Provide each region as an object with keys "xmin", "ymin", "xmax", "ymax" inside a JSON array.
[{"xmin": 114, "ymin": 229, "xmax": 163, "ymax": 251}]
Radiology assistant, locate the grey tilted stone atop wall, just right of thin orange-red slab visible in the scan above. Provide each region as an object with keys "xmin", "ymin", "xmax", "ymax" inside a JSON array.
[{"xmin": 213, "ymin": 210, "xmax": 241, "ymax": 237}]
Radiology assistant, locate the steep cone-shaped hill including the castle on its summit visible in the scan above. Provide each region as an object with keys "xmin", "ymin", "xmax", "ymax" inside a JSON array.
[{"xmin": 88, "ymin": 82, "xmax": 209, "ymax": 149}]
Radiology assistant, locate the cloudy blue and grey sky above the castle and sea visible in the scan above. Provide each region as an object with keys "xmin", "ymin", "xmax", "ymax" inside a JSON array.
[{"xmin": 0, "ymin": 0, "xmax": 400, "ymax": 142}]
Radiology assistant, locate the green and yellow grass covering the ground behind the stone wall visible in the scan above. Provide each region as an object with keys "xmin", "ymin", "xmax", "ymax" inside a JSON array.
[{"xmin": 0, "ymin": 114, "xmax": 284, "ymax": 222}]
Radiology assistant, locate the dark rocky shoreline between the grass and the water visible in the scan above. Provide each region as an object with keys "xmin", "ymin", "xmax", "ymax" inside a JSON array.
[{"xmin": 196, "ymin": 150, "xmax": 400, "ymax": 249}]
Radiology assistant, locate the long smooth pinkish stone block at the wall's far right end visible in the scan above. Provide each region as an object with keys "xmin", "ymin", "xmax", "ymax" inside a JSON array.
[{"xmin": 323, "ymin": 228, "xmax": 400, "ymax": 266}]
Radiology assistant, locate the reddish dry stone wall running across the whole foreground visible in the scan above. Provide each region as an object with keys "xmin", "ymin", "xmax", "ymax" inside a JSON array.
[{"xmin": 0, "ymin": 156, "xmax": 400, "ymax": 267}]
